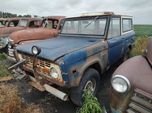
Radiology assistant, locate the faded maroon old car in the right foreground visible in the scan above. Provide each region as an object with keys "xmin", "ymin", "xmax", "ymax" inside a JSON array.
[{"xmin": 109, "ymin": 38, "xmax": 152, "ymax": 113}]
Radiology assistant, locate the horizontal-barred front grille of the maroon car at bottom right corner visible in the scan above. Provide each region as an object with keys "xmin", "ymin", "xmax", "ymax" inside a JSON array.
[{"xmin": 126, "ymin": 89, "xmax": 152, "ymax": 113}]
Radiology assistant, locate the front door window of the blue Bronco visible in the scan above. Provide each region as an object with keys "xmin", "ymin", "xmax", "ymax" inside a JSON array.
[{"xmin": 108, "ymin": 18, "xmax": 120, "ymax": 38}]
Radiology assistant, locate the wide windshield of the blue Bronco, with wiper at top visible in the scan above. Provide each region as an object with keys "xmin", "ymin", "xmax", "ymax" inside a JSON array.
[{"xmin": 61, "ymin": 17, "xmax": 107, "ymax": 35}]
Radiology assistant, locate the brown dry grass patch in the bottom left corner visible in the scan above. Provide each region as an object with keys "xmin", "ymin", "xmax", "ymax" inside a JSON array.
[{"xmin": 0, "ymin": 83, "xmax": 43, "ymax": 113}]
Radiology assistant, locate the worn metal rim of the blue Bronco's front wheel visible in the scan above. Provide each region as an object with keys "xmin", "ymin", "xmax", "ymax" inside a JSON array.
[{"xmin": 83, "ymin": 79, "xmax": 96, "ymax": 94}]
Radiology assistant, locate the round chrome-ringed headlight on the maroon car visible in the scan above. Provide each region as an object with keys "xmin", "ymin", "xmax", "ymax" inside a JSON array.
[{"xmin": 111, "ymin": 75, "xmax": 130, "ymax": 93}]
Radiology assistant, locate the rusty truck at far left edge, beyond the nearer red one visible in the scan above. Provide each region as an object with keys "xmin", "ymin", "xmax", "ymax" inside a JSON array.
[{"xmin": 0, "ymin": 18, "xmax": 42, "ymax": 53}]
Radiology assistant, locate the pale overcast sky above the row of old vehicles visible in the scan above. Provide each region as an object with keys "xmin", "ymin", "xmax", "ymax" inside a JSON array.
[{"xmin": 0, "ymin": 0, "xmax": 152, "ymax": 24}]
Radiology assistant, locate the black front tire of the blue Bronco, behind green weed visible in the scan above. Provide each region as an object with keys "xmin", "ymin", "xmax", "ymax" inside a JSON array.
[{"xmin": 70, "ymin": 68, "xmax": 100, "ymax": 106}]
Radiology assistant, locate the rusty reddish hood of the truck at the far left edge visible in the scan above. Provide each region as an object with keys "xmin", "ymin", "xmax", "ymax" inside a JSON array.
[{"xmin": 0, "ymin": 27, "xmax": 25, "ymax": 36}]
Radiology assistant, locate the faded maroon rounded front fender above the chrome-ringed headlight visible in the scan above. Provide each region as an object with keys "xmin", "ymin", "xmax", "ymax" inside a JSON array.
[{"xmin": 114, "ymin": 56, "xmax": 152, "ymax": 94}]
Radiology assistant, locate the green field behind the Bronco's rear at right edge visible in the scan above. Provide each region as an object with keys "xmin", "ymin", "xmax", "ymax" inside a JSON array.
[{"xmin": 134, "ymin": 25, "xmax": 152, "ymax": 37}]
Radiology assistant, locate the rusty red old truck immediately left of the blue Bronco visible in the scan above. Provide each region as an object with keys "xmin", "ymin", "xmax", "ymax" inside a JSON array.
[{"xmin": 8, "ymin": 16, "xmax": 64, "ymax": 59}]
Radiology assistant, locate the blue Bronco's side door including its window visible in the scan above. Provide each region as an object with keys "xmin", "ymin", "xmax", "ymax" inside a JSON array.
[{"xmin": 107, "ymin": 17, "xmax": 123, "ymax": 65}]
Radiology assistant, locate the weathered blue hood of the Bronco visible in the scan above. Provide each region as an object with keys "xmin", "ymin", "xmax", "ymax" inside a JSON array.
[{"xmin": 17, "ymin": 36, "xmax": 99, "ymax": 61}]
